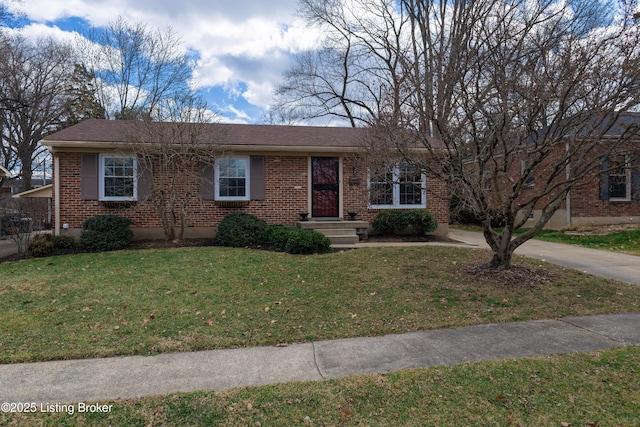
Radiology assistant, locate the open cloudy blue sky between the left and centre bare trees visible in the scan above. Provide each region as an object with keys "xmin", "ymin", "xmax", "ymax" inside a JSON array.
[{"xmin": 0, "ymin": 0, "xmax": 319, "ymax": 123}]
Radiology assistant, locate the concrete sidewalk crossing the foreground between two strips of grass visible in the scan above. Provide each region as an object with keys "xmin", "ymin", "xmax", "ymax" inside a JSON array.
[{"xmin": 0, "ymin": 313, "xmax": 640, "ymax": 403}]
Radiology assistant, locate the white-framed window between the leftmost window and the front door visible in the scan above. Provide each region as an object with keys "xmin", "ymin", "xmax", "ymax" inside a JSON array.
[{"xmin": 215, "ymin": 157, "xmax": 250, "ymax": 200}]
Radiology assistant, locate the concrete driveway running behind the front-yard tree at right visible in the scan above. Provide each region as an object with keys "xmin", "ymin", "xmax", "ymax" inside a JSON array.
[{"xmin": 449, "ymin": 229, "xmax": 640, "ymax": 285}]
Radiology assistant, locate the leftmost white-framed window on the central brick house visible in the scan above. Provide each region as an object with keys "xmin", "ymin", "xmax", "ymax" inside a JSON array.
[{"xmin": 99, "ymin": 154, "xmax": 138, "ymax": 201}]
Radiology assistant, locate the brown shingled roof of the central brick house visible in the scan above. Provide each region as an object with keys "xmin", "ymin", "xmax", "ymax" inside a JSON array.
[{"xmin": 42, "ymin": 119, "xmax": 442, "ymax": 152}]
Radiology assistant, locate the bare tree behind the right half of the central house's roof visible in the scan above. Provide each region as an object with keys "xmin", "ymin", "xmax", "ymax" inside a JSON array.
[{"xmin": 273, "ymin": 0, "xmax": 406, "ymax": 127}]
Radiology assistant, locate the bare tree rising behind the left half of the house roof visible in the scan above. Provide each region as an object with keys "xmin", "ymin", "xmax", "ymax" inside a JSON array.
[{"xmin": 78, "ymin": 17, "xmax": 193, "ymax": 119}]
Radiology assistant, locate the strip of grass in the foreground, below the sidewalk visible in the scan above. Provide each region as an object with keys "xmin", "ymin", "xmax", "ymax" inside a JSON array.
[{"xmin": 0, "ymin": 347, "xmax": 640, "ymax": 427}]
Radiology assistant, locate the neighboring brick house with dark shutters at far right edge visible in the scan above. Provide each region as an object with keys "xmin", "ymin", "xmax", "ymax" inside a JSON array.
[{"xmin": 525, "ymin": 113, "xmax": 640, "ymax": 230}]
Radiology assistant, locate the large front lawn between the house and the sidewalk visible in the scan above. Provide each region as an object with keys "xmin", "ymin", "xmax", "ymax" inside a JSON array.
[{"xmin": 0, "ymin": 247, "xmax": 640, "ymax": 363}]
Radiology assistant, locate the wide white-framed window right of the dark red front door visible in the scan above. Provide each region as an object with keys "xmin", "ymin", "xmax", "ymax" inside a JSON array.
[{"xmin": 369, "ymin": 161, "xmax": 426, "ymax": 208}]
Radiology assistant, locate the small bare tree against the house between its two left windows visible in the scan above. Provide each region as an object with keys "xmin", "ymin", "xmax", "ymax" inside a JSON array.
[{"xmin": 122, "ymin": 94, "xmax": 224, "ymax": 240}]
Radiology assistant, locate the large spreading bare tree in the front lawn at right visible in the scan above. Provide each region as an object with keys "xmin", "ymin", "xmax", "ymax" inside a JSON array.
[{"xmin": 292, "ymin": 0, "xmax": 640, "ymax": 268}]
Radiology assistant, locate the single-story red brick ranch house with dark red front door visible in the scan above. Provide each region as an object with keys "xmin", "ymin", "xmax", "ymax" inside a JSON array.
[{"xmin": 42, "ymin": 120, "xmax": 449, "ymax": 242}]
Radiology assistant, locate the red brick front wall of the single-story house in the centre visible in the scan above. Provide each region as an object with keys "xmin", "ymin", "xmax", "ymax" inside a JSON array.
[{"xmin": 58, "ymin": 153, "xmax": 449, "ymax": 237}]
